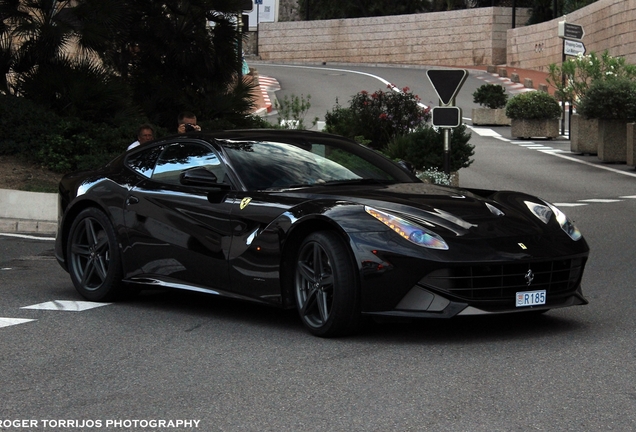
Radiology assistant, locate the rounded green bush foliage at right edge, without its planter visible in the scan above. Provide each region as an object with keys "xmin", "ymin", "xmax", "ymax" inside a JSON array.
[{"xmin": 577, "ymin": 78, "xmax": 636, "ymax": 120}]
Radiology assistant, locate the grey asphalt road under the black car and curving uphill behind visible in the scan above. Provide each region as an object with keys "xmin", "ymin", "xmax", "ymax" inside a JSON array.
[{"xmin": 0, "ymin": 65, "xmax": 636, "ymax": 431}]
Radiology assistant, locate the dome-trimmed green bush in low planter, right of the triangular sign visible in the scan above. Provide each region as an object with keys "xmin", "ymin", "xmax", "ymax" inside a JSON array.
[{"xmin": 506, "ymin": 91, "xmax": 561, "ymax": 138}]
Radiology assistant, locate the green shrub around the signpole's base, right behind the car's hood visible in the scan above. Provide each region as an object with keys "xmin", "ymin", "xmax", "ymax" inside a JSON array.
[{"xmin": 387, "ymin": 125, "xmax": 475, "ymax": 171}]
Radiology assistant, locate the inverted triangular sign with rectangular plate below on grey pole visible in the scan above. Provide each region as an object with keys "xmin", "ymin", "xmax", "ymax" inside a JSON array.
[{"xmin": 426, "ymin": 69, "xmax": 468, "ymax": 175}]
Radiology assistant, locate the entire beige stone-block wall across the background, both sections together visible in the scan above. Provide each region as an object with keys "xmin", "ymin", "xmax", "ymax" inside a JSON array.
[{"xmin": 253, "ymin": 0, "xmax": 636, "ymax": 71}]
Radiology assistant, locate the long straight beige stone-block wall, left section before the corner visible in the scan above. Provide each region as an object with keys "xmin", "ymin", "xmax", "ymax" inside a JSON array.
[{"xmin": 258, "ymin": 7, "xmax": 528, "ymax": 66}]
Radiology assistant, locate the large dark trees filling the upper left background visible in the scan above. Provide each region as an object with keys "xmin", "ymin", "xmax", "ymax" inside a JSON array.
[{"xmin": 0, "ymin": 0, "xmax": 253, "ymax": 129}]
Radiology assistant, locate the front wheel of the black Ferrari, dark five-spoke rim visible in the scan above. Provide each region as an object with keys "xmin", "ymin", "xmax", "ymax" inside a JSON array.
[{"xmin": 294, "ymin": 231, "xmax": 360, "ymax": 337}]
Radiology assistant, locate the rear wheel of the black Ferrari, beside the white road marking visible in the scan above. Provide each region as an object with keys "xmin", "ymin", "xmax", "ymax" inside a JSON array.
[{"xmin": 66, "ymin": 208, "xmax": 124, "ymax": 301}]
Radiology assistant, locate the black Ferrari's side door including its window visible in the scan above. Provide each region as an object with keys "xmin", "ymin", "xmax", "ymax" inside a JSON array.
[{"xmin": 124, "ymin": 140, "xmax": 233, "ymax": 289}]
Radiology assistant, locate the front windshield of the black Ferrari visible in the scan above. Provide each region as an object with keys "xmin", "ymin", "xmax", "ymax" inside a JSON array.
[{"xmin": 224, "ymin": 142, "xmax": 404, "ymax": 190}]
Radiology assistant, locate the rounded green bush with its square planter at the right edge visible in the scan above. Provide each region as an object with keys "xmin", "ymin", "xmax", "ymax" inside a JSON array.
[{"xmin": 577, "ymin": 77, "xmax": 636, "ymax": 162}]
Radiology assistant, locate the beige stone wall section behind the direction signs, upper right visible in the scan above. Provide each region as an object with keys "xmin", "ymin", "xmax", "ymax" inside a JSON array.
[{"xmin": 506, "ymin": 0, "xmax": 636, "ymax": 71}]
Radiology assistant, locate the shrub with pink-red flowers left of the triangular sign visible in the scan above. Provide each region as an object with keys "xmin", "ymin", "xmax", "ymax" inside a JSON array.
[{"xmin": 325, "ymin": 86, "xmax": 430, "ymax": 150}]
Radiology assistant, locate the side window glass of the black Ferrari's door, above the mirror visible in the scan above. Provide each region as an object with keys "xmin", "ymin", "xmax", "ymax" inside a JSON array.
[{"xmin": 152, "ymin": 143, "xmax": 225, "ymax": 184}]
